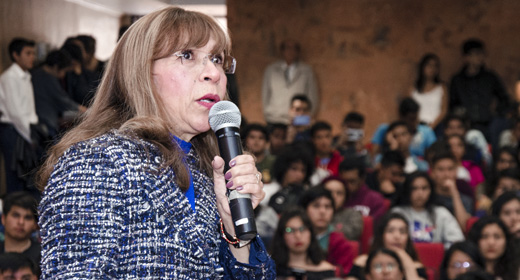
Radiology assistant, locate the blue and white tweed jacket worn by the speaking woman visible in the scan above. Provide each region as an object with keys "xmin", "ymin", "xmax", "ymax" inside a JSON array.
[{"xmin": 39, "ymin": 131, "xmax": 276, "ymax": 279}]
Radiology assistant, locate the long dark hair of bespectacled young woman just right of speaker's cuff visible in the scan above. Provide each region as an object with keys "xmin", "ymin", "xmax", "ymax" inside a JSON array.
[{"xmin": 270, "ymin": 208, "xmax": 325, "ymax": 269}]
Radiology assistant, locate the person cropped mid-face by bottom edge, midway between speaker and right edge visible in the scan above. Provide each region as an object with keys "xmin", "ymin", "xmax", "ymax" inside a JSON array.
[{"xmin": 365, "ymin": 248, "xmax": 410, "ymax": 280}]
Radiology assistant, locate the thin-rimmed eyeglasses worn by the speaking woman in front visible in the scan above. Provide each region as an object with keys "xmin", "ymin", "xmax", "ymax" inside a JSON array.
[{"xmin": 173, "ymin": 50, "xmax": 237, "ymax": 74}]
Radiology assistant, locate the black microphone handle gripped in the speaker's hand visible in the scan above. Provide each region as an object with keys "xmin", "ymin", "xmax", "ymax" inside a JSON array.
[{"xmin": 215, "ymin": 127, "xmax": 257, "ymax": 241}]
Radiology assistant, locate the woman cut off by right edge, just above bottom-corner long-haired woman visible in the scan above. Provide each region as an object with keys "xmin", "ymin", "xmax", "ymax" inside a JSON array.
[{"xmin": 491, "ymin": 191, "xmax": 520, "ymax": 240}]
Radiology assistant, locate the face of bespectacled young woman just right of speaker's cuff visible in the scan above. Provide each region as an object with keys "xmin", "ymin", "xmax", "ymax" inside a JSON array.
[{"xmin": 283, "ymin": 217, "xmax": 311, "ymax": 253}]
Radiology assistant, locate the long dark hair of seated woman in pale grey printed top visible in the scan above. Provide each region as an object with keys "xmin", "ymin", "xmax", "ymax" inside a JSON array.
[{"xmin": 397, "ymin": 171, "xmax": 435, "ymax": 218}]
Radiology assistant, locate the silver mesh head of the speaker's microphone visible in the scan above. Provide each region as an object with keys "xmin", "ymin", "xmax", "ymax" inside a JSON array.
[{"xmin": 209, "ymin": 101, "xmax": 242, "ymax": 132}]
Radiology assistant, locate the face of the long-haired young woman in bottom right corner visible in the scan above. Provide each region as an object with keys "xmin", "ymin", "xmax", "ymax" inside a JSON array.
[{"xmin": 478, "ymin": 224, "xmax": 506, "ymax": 261}]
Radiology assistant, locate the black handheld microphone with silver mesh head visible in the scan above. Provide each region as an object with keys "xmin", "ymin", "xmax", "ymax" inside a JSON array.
[{"xmin": 209, "ymin": 101, "xmax": 256, "ymax": 241}]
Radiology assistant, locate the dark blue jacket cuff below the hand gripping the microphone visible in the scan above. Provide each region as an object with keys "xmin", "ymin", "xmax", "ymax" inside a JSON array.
[{"xmin": 220, "ymin": 235, "xmax": 276, "ymax": 280}]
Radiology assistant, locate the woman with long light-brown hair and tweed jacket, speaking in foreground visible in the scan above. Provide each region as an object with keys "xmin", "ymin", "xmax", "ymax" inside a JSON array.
[{"xmin": 35, "ymin": 7, "xmax": 275, "ymax": 279}]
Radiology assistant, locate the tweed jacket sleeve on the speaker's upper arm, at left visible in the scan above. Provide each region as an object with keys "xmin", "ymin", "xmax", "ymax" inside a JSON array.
[{"xmin": 39, "ymin": 145, "xmax": 124, "ymax": 279}]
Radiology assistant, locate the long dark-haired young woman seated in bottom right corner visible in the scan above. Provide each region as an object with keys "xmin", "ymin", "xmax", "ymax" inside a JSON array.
[{"xmin": 468, "ymin": 216, "xmax": 520, "ymax": 280}]
